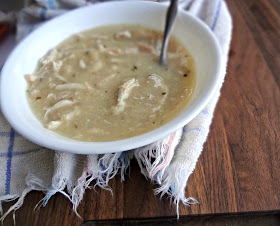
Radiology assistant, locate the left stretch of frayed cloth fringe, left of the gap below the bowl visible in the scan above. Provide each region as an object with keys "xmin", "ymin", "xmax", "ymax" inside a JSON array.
[{"xmin": 0, "ymin": 152, "xmax": 133, "ymax": 223}]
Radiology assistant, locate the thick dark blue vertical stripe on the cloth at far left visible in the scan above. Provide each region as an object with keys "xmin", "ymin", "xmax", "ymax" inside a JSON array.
[{"xmin": 5, "ymin": 128, "xmax": 15, "ymax": 195}]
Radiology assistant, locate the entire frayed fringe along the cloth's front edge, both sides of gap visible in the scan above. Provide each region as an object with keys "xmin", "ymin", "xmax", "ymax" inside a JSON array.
[{"xmin": 0, "ymin": 138, "xmax": 198, "ymax": 222}]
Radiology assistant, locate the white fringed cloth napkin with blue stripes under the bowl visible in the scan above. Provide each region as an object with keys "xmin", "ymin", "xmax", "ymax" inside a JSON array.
[{"xmin": 0, "ymin": 0, "xmax": 232, "ymax": 220}]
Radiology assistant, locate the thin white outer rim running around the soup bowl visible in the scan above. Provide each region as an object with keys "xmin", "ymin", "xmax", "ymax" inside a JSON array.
[{"xmin": 0, "ymin": 1, "xmax": 223, "ymax": 154}]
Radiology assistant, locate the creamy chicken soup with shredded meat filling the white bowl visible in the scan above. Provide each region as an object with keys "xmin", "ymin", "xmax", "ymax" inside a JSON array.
[{"xmin": 25, "ymin": 25, "xmax": 195, "ymax": 141}]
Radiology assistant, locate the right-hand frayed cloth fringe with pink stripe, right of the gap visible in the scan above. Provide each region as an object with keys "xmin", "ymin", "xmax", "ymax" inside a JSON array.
[{"xmin": 134, "ymin": 129, "xmax": 198, "ymax": 218}]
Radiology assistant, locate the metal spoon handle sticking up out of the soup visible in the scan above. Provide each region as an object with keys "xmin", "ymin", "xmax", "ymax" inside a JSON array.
[{"xmin": 159, "ymin": 0, "xmax": 178, "ymax": 66}]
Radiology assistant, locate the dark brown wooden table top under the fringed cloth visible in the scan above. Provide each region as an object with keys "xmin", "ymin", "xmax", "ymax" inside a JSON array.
[{"xmin": 4, "ymin": 0, "xmax": 280, "ymax": 225}]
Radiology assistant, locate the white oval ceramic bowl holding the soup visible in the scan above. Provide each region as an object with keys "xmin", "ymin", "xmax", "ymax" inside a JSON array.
[{"xmin": 0, "ymin": 1, "xmax": 221, "ymax": 154}]
